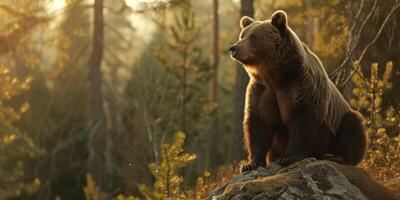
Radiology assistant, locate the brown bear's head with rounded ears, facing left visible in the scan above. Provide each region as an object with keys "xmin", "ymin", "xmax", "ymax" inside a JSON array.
[{"xmin": 229, "ymin": 10, "xmax": 289, "ymax": 67}]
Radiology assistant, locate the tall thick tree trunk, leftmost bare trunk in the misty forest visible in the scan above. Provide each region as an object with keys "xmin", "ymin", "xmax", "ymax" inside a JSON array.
[{"xmin": 88, "ymin": 0, "xmax": 107, "ymax": 189}]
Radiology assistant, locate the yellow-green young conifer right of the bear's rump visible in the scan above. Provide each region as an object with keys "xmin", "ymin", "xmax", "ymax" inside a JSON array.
[{"xmin": 350, "ymin": 62, "xmax": 400, "ymax": 179}]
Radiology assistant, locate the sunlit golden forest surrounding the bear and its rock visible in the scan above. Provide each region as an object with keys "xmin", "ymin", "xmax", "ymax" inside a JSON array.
[{"xmin": 0, "ymin": 0, "xmax": 400, "ymax": 200}]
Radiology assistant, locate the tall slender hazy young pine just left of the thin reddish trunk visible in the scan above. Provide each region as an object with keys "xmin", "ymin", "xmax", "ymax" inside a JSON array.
[{"xmin": 155, "ymin": 0, "xmax": 213, "ymax": 134}]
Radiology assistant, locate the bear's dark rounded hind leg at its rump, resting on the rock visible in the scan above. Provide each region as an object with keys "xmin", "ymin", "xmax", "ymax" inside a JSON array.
[{"xmin": 331, "ymin": 111, "xmax": 367, "ymax": 165}]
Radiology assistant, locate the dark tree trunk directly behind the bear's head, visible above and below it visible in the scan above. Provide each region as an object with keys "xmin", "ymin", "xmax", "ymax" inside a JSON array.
[{"xmin": 229, "ymin": 0, "xmax": 254, "ymax": 162}]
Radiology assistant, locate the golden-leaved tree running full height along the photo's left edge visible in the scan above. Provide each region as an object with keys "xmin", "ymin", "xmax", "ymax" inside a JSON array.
[{"xmin": 0, "ymin": 1, "xmax": 48, "ymax": 199}]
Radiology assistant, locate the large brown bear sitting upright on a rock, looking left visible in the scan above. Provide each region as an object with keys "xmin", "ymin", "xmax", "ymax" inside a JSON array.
[{"xmin": 229, "ymin": 11, "xmax": 367, "ymax": 171}]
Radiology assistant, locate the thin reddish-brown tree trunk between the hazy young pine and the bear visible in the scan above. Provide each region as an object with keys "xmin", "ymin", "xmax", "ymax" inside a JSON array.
[{"xmin": 207, "ymin": 0, "xmax": 219, "ymax": 168}]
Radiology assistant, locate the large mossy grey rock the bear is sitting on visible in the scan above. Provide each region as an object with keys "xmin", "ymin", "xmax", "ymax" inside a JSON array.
[{"xmin": 207, "ymin": 158, "xmax": 396, "ymax": 200}]
